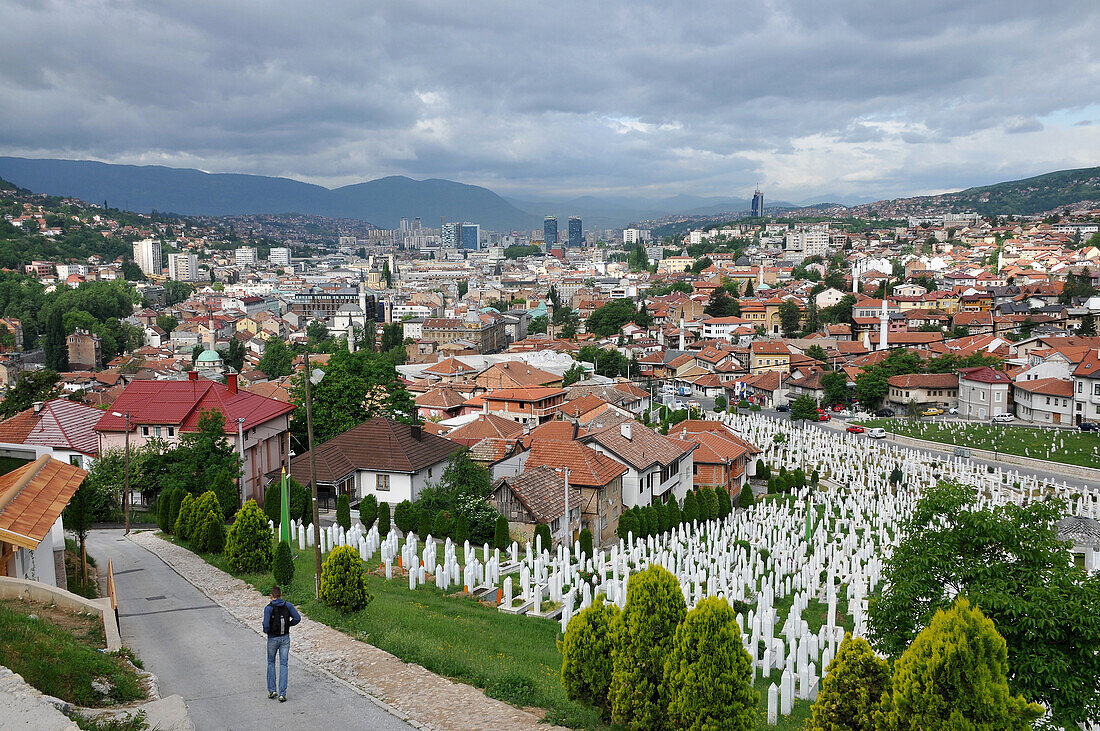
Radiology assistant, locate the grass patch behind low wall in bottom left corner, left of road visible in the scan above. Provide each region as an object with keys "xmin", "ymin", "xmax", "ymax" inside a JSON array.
[{"xmin": 0, "ymin": 601, "xmax": 144, "ymax": 707}]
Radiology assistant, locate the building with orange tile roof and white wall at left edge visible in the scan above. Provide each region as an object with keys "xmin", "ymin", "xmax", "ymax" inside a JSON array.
[{"xmin": 0, "ymin": 454, "xmax": 88, "ymax": 589}]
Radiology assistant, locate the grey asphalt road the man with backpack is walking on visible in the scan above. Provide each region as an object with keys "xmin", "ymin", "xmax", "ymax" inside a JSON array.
[{"xmin": 88, "ymin": 530, "xmax": 411, "ymax": 731}]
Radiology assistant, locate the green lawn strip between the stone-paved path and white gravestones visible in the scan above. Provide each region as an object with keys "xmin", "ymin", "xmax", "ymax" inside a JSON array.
[{"xmin": 171, "ymin": 539, "xmax": 820, "ymax": 731}]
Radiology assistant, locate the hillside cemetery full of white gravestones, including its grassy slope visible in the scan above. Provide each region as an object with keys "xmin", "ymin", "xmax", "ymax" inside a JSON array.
[{"xmin": 167, "ymin": 413, "xmax": 1100, "ymax": 728}]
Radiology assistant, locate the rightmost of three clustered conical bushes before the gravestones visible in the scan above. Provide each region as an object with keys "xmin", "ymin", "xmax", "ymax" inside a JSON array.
[{"xmin": 664, "ymin": 597, "xmax": 760, "ymax": 731}]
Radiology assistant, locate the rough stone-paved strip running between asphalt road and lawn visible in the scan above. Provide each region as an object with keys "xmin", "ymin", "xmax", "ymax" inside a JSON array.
[{"xmin": 130, "ymin": 531, "xmax": 558, "ymax": 731}]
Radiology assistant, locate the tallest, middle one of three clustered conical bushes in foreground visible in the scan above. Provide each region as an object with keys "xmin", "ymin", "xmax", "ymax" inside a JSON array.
[{"xmin": 609, "ymin": 566, "xmax": 688, "ymax": 729}]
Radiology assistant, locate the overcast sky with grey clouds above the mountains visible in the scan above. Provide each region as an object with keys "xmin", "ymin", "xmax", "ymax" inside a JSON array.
[{"xmin": 0, "ymin": 0, "xmax": 1100, "ymax": 201}]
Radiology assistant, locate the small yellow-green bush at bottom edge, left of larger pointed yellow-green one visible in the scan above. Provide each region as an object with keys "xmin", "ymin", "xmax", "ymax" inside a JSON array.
[{"xmin": 806, "ymin": 632, "xmax": 890, "ymax": 731}]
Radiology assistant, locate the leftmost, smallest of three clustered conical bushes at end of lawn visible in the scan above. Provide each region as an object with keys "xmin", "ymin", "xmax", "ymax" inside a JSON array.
[{"xmin": 558, "ymin": 594, "xmax": 622, "ymax": 723}]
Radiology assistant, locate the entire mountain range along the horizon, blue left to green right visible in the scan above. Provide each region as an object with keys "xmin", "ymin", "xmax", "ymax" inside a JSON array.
[{"xmin": 0, "ymin": 157, "xmax": 1100, "ymax": 230}]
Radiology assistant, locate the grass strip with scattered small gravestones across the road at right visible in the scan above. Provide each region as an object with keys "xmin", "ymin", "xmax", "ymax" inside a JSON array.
[{"xmin": 859, "ymin": 419, "xmax": 1100, "ymax": 467}]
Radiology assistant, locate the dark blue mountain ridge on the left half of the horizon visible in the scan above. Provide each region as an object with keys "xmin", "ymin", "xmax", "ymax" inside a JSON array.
[{"xmin": 0, "ymin": 157, "xmax": 541, "ymax": 231}]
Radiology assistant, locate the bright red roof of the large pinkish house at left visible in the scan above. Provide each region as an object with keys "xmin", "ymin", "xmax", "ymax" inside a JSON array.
[{"xmin": 96, "ymin": 379, "xmax": 295, "ymax": 434}]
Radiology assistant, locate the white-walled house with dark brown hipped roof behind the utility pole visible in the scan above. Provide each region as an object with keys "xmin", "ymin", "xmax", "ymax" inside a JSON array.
[{"xmin": 290, "ymin": 417, "xmax": 465, "ymax": 506}]
